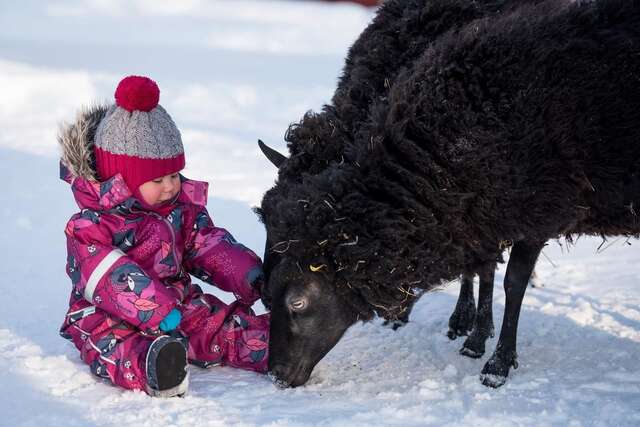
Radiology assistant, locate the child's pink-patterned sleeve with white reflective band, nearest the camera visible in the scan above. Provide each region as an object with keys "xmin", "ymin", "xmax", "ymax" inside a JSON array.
[{"xmin": 65, "ymin": 215, "xmax": 178, "ymax": 334}]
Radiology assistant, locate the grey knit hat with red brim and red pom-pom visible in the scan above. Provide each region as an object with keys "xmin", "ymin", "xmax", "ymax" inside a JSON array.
[{"xmin": 95, "ymin": 76, "xmax": 185, "ymax": 192}]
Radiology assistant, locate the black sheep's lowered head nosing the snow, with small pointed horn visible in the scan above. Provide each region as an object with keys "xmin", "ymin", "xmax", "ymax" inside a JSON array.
[{"xmin": 258, "ymin": 140, "xmax": 358, "ymax": 387}]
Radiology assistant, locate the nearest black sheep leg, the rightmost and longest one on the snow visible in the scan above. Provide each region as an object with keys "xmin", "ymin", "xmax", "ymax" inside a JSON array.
[{"xmin": 480, "ymin": 241, "xmax": 544, "ymax": 387}]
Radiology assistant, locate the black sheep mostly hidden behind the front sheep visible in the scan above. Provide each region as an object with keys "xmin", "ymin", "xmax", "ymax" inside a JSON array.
[{"xmin": 261, "ymin": 0, "xmax": 540, "ymax": 344}]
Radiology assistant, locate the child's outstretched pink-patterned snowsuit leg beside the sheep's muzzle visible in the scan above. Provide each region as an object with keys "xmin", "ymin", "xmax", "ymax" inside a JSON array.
[{"xmin": 180, "ymin": 294, "xmax": 270, "ymax": 373}]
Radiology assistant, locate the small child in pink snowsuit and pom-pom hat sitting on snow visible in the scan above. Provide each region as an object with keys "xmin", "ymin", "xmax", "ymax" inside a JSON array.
[{"xmin": 59, "ymin": 76, "xmax": 269, "ymax": 396}]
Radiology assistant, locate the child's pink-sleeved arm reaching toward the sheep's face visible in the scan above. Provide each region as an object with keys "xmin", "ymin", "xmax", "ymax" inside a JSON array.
[{"xmin": 184, "ymin": 207, "xmax": 263, "ymax": 305}]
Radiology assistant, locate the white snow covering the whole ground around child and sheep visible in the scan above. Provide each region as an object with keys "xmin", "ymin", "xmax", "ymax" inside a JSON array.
[{"xmin": 0, "ymin": 0, "xmax": 640, "ymax": 427}]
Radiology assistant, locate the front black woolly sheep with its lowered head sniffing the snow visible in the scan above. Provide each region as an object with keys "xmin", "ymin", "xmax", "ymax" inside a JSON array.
[{"xmin": 260, "ymin": 0, "xmax": 640, "ymax": 386}]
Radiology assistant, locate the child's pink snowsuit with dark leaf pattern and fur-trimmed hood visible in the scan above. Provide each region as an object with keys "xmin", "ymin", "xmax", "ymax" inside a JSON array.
[{"xmin": 60, "ymin": 106, "xmax": 269, "ymax": 390}]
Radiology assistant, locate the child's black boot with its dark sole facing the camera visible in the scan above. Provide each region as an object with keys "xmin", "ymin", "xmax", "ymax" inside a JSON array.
[{"xmin": 147, "ymin": 335, "xmax": 189, "ymax": 397}]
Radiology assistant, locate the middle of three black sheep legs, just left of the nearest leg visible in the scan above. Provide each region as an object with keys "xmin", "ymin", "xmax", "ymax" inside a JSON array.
[{"xmin": 460, "ymin": 262, "xmax": 496, "ymax": 358}]
